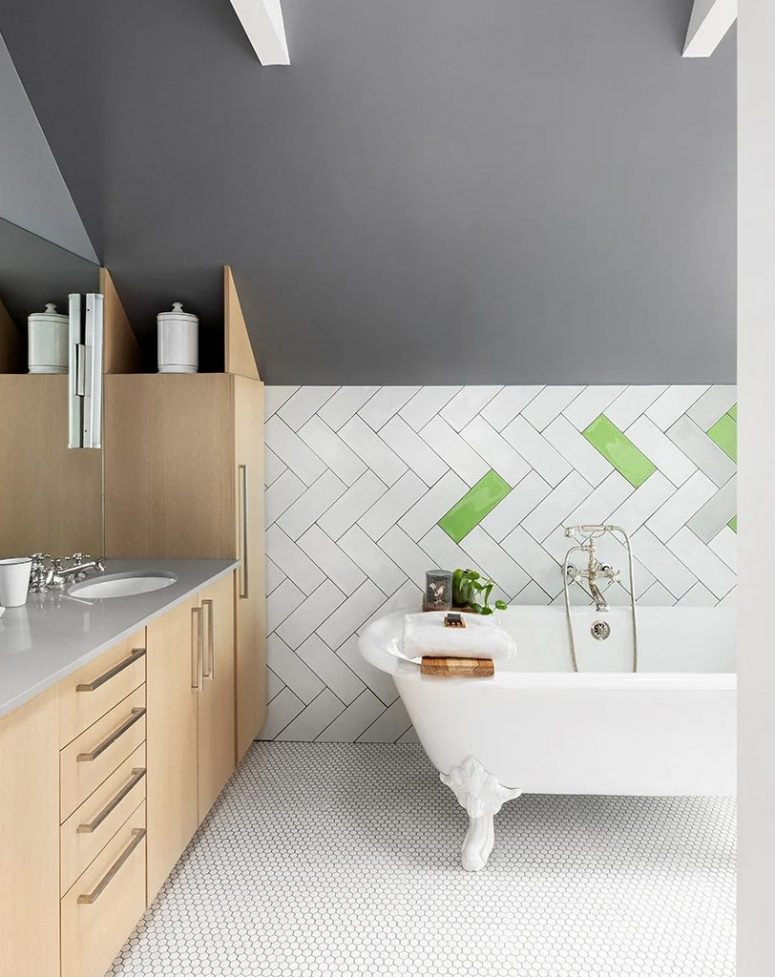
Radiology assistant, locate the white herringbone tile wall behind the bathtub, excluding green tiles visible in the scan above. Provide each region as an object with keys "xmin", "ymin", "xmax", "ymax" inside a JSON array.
[{"xmin": 262, "ymin": 386, "xmax": 736, "ymax": 742}]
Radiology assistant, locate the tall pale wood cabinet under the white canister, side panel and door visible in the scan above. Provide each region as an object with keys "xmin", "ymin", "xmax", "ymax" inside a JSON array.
[{"xmin": 104, "ymin": 373, "xmax": 266, "ymax": 759}]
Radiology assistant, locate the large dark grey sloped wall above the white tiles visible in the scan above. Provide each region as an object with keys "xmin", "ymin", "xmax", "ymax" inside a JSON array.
[{"xmin": 0, "ymin": 0, "xmax": 735, "ymax": 384}]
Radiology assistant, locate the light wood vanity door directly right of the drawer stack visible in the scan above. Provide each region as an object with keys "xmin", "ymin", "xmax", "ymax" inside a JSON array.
[{"xmin": 146, "ymin": 600, "xmax": 202, "ymax": 903}]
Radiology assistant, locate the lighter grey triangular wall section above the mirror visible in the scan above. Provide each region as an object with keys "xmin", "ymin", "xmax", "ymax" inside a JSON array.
[{"xmin": 0, "ymin": 37, "xmax": 97, "ymax": 270}]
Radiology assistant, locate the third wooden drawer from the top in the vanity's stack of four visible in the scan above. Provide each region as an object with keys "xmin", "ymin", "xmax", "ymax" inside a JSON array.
[{"xmin": 60, "ymin": 743, "xmax": 145, "ymax": 895}]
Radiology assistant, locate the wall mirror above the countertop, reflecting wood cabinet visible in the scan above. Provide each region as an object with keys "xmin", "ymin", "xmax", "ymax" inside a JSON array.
[{"xmin": 0, "ymin": 219, "xmax": 103, "ymax": 558}]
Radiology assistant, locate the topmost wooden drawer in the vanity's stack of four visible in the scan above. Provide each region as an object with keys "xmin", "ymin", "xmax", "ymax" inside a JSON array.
[{"xmin": 58, "ymin": 630, "xmax": 145, "ymax": 746}]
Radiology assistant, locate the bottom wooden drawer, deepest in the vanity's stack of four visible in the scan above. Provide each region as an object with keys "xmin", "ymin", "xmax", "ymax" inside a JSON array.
[{"xmin": 61, "ymin": 802, "xmax": 145, "ymax": 977}]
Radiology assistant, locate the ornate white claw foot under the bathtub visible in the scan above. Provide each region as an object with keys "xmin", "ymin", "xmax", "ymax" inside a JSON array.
[{"xmin": 439, "ymin": 756, "xmax": 522, "ymax": 872}]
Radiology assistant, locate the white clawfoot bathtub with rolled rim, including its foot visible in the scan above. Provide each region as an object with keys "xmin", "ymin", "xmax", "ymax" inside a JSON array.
[{"xmin": 360, "ymin": 607, "xmax": 736, "ymax": 871}]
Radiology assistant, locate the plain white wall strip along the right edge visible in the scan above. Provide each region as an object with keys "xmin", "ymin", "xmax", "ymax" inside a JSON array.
[{"xmin": 738, "ymin": 0, "xmax": 775, "ymax": 977}]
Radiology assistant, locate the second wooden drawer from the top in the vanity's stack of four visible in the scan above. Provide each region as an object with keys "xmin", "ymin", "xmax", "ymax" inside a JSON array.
[{"xmin": 59, "ymin": 685, "xmax": 145, "ymax": 821}]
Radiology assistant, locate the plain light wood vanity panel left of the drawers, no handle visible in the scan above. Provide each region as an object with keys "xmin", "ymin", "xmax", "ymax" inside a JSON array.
[{"xmin": 0, "ymin": 689, "xmax": 59, "ymax": 977}]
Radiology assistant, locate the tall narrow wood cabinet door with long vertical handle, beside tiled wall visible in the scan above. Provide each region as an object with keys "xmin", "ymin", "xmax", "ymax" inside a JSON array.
[{"xmin": 232, "ymin": 376, "xmax": 266, "ymax": 760}]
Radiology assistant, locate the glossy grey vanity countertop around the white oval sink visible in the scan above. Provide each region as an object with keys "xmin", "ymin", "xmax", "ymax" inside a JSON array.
[{"xmin": 0, "ymin": 560, "xmax": 238, "ymax": 716}]
